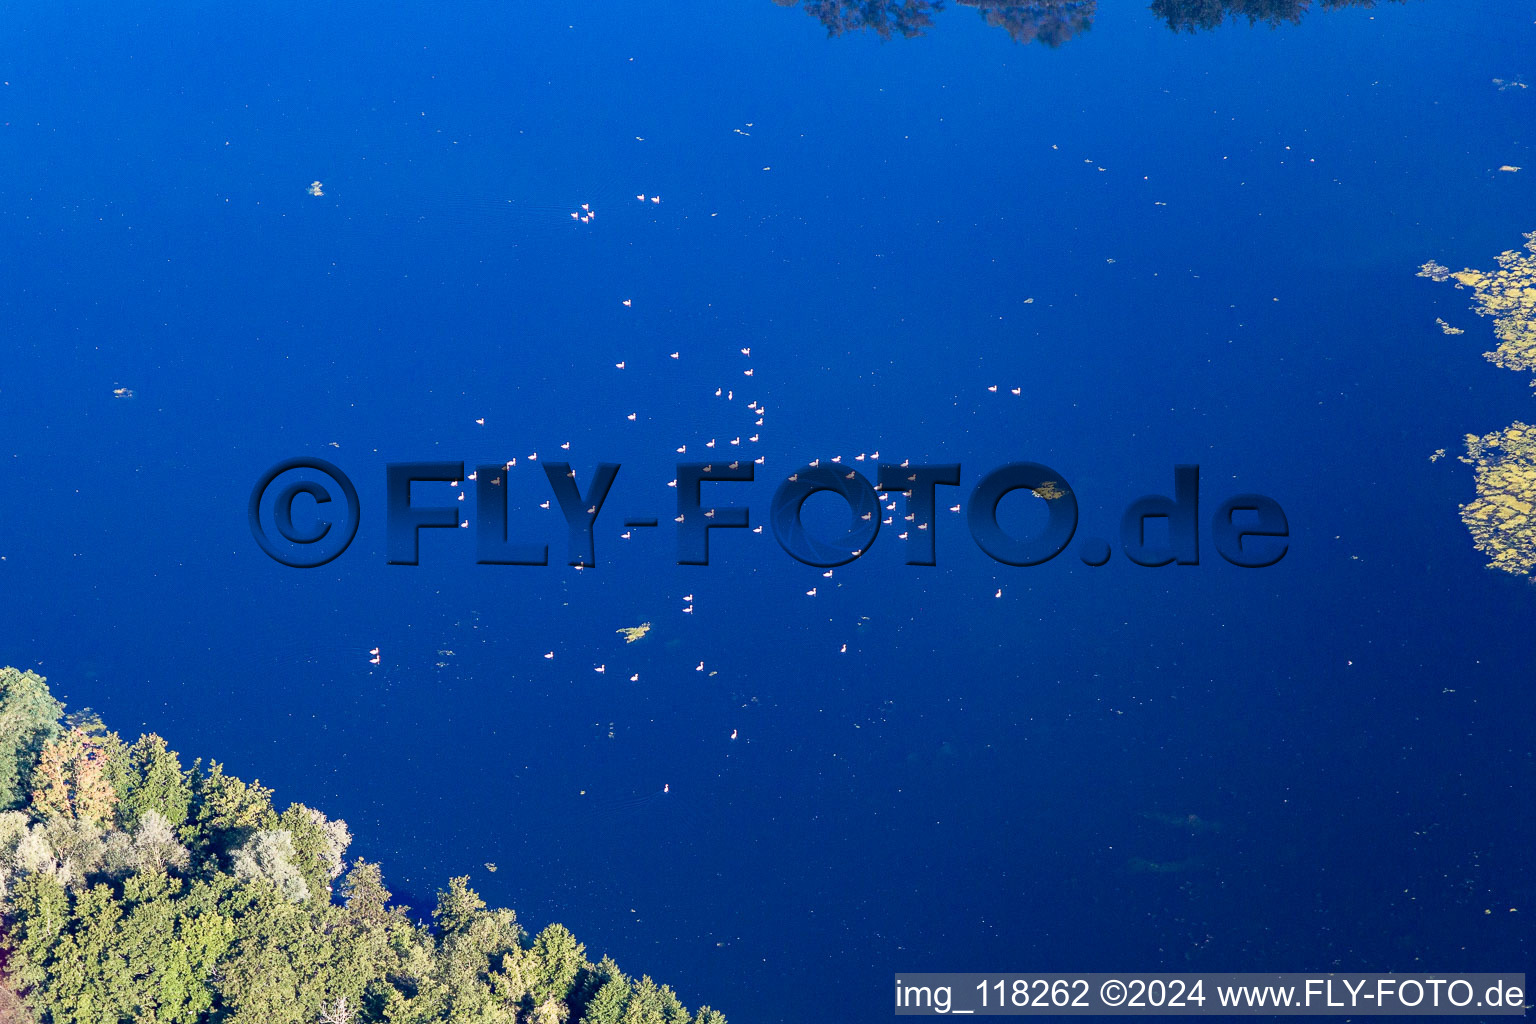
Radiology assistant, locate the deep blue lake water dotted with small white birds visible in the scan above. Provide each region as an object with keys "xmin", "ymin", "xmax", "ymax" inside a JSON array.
[{"xmin": 0, "ymin": 0, "xmax": 1536, "ymax": 1024}]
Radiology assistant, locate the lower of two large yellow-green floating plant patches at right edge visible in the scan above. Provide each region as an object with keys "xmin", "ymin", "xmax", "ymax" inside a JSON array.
[{"xmin": 1461, "ymin": 422, "xmax": 1536, "ymax": 579}]
